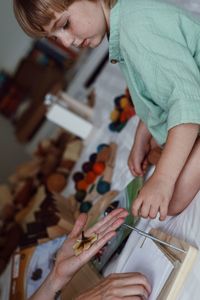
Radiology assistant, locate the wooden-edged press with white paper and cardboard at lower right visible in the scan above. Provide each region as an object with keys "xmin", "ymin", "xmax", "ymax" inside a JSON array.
[{"xmin": 121, "ymin": 229, "xmax": 198, "ymax": 300}]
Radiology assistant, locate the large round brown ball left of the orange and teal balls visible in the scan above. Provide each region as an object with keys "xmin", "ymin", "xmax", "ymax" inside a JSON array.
[{"xmin": 46, "ymin": 173, "xmax": 67, "ymax": 192}]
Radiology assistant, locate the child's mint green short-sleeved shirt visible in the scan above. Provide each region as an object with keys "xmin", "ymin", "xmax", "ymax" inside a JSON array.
[{"xmin": 109, "ymin": 0, "xmax": 200, "ymax": 145}]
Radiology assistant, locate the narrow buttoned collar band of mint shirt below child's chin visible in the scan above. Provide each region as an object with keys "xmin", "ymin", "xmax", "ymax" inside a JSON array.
[{"xmin": 109, "ymin": 0, "xmax": 121, "ymax": 63}]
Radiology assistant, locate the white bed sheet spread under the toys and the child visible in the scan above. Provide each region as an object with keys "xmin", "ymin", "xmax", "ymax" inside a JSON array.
[{"xmin": 64, "ymin": 108, "xmax": 200, "ymax": 300}]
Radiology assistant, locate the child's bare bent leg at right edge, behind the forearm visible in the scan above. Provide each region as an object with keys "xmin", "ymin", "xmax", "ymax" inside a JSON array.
[{"xmin": 168, "ymin": 138, "xmax": 200, "ymax": 215}]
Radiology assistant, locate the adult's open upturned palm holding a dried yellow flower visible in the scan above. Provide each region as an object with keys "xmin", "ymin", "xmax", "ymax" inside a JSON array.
[{"xmin": 51, "ymin": 208, "xmax": 128, "ymax": 291}]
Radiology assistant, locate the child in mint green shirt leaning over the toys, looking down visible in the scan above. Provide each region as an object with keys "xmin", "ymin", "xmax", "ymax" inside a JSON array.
[{"xmin": 14, "ymin": 0, "xmax": 200, "ymax": 220}]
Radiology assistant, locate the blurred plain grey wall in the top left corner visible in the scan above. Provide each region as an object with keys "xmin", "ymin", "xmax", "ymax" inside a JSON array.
[{"xmin": 0, "ymin": 0, "xmax": 31, "ymax": 73}]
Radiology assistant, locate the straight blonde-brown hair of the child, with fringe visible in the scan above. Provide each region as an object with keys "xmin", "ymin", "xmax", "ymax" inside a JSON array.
[{"xmin": 13, "ymin": 0, "xmax": 117, "ymax": 37}]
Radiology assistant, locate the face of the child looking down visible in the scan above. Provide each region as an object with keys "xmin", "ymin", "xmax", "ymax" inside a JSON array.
[{"xmin": 44, "ymin": 0, "xmax": 108, "ymax": 48}]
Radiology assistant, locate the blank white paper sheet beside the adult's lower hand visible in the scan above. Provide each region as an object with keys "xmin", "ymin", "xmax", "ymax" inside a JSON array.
[{"xmin": 122, "ymin": 237, "xmax": 174, "ymax": 300}]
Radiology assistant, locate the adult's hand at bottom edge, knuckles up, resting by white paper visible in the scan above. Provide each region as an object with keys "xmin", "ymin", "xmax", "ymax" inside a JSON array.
[{"xmin": 76, "ymin": 273, "xmax": 151, "ymax": 300}]
